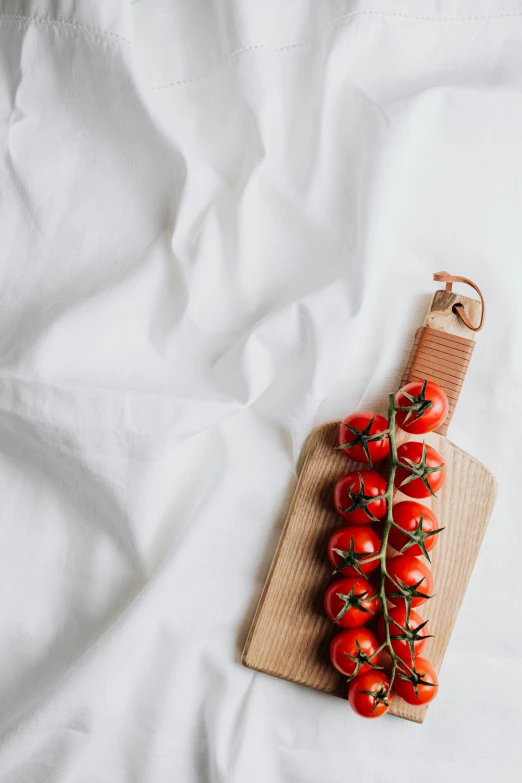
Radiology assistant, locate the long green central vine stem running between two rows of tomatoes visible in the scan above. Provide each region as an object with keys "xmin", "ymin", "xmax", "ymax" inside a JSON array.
[{"xmin": 378, "ymin": 394, "xmax": 413, "ymax": 696}]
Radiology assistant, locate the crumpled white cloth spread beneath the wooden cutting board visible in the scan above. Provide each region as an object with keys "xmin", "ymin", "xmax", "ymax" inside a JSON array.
[{"xmin": 0, "ymin": 0, "xmax": 522, "ymax": 783}]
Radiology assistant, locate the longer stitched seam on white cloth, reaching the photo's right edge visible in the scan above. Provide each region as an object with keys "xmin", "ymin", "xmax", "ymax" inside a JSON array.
[{"xmin": 149, "ymin": 8, "xmax": 522, "ymax": 90}]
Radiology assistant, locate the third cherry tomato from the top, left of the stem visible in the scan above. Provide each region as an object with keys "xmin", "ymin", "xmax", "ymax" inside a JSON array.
[{"xmin": 327, "ymin": 525, "xmax": 381, "ymax": 576}]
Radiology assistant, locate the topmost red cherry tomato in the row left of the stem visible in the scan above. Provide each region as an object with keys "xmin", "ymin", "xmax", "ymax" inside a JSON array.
[{"xmin": 339, "ymin": 411, "xmax": 390, "ymax": 465}]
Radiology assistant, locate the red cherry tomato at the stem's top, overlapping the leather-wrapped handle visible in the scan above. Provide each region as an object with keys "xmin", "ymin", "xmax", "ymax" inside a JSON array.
[{"xmin": 395, "ymin": 381, "xmax": 449, "ymax": 435}]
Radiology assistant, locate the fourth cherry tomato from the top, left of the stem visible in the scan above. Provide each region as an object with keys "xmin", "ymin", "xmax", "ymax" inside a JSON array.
[{"xmin": 324, "ymin": 576, "xmax": 378, "ymax": 628}]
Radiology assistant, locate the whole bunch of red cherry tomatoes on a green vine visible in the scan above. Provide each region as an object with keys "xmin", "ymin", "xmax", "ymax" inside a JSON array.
[{"xmin": 324, "ymin": 380, "xmax": 448, "ymax": 718}]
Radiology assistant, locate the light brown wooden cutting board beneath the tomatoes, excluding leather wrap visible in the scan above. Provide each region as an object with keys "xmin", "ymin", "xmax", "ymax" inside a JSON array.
[{"xmin": 242, "ymin": 280, "xmax": 497, "ymax": 723}]
